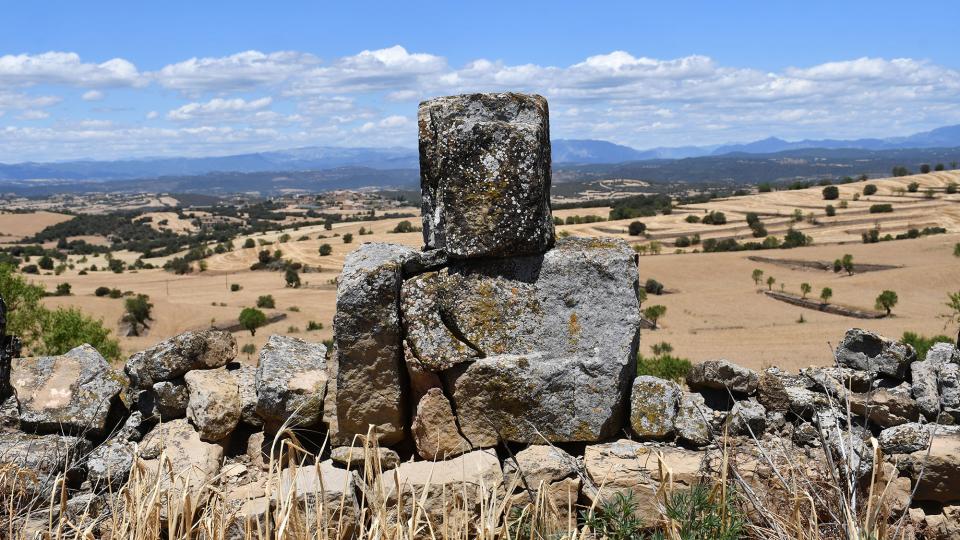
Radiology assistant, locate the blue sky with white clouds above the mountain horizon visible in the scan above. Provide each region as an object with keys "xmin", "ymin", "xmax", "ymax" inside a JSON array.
[{"xmin": 0, "ymin": 1, "xmax": 960, "ymax": 162}]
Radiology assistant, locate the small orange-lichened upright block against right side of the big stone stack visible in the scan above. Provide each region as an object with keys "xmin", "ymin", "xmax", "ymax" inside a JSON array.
[{"xmin": 630, "ymin": 375, "xmax": 680, "ymax": 439}]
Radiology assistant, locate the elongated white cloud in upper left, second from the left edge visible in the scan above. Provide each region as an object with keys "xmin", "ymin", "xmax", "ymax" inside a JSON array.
[{"xmin": 151, "ymin": 51, "xmax": 320, "ymax": 93}]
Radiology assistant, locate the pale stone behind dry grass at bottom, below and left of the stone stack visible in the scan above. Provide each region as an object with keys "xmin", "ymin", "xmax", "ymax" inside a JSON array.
[{"xmin": 273, "ymin": 460, "xmax": 360, "ymax": 538}]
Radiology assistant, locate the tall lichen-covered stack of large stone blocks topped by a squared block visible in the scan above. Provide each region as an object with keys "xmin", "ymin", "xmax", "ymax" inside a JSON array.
[{"xmin": 334, "ymin": 93, "xmax": 640, "ymax": 459}]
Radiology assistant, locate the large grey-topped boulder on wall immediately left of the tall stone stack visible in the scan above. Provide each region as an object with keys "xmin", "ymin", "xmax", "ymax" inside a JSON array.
[{"xmin": 256, "ymin": 335, "xmax": 328, "ymax": 432}]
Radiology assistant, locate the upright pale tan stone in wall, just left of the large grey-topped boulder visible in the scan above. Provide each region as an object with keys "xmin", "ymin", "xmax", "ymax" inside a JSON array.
[{"xmin": 183, "ymin": 368, "xmax": 240, "ymax": 441}]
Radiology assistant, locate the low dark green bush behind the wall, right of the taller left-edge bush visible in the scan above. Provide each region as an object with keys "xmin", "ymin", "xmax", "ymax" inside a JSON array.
[{"xmin": 36, "ymin": 308, "xmax": 120, "ymax": 360}]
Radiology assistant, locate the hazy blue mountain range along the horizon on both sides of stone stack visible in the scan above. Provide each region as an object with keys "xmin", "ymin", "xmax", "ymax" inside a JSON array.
[{"xmin": 0, "ymin": 125, "xmax": 960, "ymax": 193}]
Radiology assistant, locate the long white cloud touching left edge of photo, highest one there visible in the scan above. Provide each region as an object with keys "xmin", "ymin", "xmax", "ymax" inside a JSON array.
[{"xmin": 0, "ymin": 51, "xmax": 146, "ymax": 88}]
